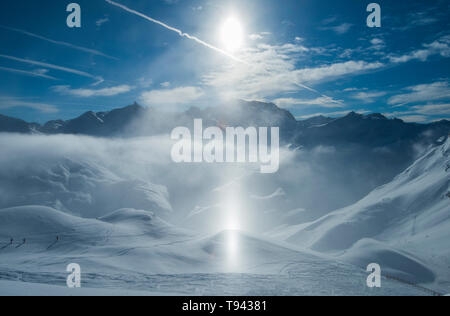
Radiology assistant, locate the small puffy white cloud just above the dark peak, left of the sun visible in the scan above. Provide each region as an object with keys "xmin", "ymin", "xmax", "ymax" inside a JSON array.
[{"xmin": 140, "ymin": 87, "xmax": 204, "ymax": 106}]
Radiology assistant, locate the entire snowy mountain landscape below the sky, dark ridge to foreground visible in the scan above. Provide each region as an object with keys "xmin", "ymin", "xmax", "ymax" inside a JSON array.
[{"xmin": 0, "ymin": 102, "xmax": 450, "ymax": 295}]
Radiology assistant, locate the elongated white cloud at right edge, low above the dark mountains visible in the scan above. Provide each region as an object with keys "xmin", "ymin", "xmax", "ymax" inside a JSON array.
[{"xmin": 388, "ymin": 81, "xmax": 450, "ymax": 105}]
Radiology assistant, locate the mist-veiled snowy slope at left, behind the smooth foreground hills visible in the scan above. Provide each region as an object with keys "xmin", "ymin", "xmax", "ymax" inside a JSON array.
[{"xmin": 0, "ymin": 134, "xmax": 172, "ymax": 218}]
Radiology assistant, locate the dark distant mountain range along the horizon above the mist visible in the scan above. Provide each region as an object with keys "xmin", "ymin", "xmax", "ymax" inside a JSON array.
[{"xmin": 0, "ymin": 101, "xmax": 450, "ymax": 147}]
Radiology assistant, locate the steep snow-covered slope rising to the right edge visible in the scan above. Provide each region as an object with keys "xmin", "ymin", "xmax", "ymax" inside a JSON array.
[{"xmin": 287, "ymin": 138, "xmax": 450, "ymax": 287}]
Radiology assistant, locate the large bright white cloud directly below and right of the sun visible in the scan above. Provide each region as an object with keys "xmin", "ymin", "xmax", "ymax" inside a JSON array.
[{"xmin": 202, "ymin": 43, "xmax": 384, "ymax": 100}]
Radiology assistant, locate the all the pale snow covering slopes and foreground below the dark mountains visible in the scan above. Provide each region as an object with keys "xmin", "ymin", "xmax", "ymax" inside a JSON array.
[{"xmin": 0, "ymin": 135, "xmax": 450, "ymax": 295}]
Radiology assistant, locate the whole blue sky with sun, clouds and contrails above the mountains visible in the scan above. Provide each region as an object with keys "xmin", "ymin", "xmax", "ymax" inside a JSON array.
[{"xmin": 0, "ymin": 0, "xmax": 450, "ymax": 122}]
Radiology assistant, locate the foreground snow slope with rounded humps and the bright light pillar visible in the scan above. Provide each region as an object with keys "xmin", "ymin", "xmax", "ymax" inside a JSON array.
[{"xmin": 0, "ymin": 206, "xmax": 428, "ymax": 295}]
